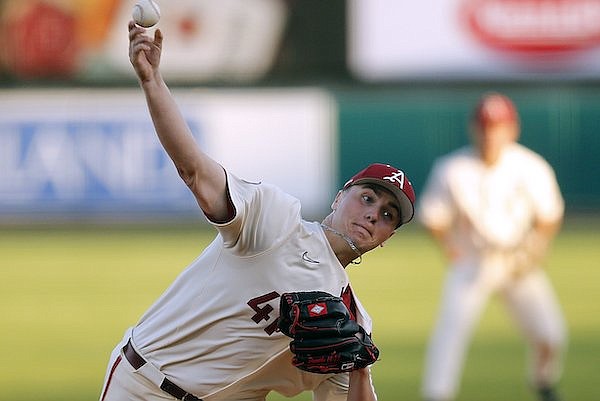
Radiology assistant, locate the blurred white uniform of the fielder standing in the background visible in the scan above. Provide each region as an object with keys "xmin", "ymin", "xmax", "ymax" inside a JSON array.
[{"xmin": 418, "ymin": 143, "xmax": 565, "ymax": 400}]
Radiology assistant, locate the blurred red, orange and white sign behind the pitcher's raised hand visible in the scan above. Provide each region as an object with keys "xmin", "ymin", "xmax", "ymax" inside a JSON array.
[{"xmin": 0, "ymin": 0, "xmax": 287, "ymax": 82}]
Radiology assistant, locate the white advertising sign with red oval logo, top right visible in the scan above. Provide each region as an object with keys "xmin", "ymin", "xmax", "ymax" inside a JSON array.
[{"xmin": 348, "ymin": 0, "xmax": 600, "ymax": 81}]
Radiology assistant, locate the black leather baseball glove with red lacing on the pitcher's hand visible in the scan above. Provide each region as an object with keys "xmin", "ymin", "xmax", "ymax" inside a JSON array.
[{"xmin": 278, "ymin": 291, "xmax": 379, "ymax": 374}]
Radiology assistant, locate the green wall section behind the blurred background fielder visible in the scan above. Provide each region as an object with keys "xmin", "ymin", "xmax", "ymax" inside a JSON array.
[{"xmin": 336, "ymin": 86, "xmax": 600, "ymax": 211}]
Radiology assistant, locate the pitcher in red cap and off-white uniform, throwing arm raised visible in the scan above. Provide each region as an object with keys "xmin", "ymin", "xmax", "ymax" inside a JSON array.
[{"xmin": 100, "ymin": 22, "xmax": 415, "ymax": 401}]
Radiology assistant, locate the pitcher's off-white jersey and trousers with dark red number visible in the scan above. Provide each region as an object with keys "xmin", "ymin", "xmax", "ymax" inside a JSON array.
[{"xmin": 103, "ymin": 170, "xmax": 378, "ymax": 401}]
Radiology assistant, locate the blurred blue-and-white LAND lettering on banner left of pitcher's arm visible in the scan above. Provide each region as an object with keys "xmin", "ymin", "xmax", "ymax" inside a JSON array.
[{"xmin": 0, "ymin": 121, "xmax": 203, "ymax": 203}]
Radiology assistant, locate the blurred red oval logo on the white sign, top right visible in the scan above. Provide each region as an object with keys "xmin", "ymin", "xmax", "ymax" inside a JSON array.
[{"xmin": 463, "ymin": 0, "xmax": 600, "ymax": 54}]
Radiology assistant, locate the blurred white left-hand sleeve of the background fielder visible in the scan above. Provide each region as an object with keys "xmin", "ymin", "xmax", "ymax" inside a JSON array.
[{"xmin": 417, "ymin": 160, "xmax": 455, "ymax": 228}]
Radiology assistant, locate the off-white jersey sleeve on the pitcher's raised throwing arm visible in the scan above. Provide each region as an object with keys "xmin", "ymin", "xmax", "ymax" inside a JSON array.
[{"xmin": 213, "ymin": 173, "xmax": 301, "ymax": 255}]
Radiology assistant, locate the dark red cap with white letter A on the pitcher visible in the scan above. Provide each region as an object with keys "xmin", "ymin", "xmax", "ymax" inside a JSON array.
[{"xmin": 343, "ymin": 163, "xmax": 415, "ymax": 226}]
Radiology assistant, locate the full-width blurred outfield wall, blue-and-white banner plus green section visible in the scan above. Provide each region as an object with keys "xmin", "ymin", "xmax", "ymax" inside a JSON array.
[{"xmin": 0, "ymin": 87, "xmax": 600, "ymax": 223}]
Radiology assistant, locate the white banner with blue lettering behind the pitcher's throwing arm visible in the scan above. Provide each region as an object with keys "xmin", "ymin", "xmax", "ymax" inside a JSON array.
[{"xmin": 0, "ymin": 89, "xmax": 336, "ymax": 220}]
